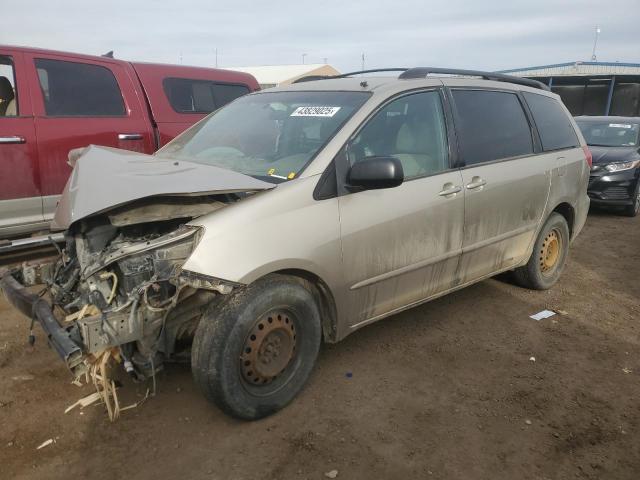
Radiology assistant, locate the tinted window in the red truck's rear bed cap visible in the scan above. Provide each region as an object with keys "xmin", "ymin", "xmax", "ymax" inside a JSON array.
[{"xmin": 162, "ymin": 78, "xmax": 249, "ymax": 113}]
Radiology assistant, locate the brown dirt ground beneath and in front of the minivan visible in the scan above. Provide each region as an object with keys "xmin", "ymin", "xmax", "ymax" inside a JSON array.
[{"xmin": 0, "ymin": 212, "xmax": 640, "ymax": 480}]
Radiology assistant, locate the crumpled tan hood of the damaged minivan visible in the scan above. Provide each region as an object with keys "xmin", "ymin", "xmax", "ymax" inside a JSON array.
[{"xmin": 51, "ymin": 145, "xmax": 275, "ymax": 230}]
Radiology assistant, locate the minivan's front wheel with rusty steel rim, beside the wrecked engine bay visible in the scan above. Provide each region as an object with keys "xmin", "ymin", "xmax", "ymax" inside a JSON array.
[{"xmin": 191, "ymin": 274, "xmax": 322, "ymax": 420}]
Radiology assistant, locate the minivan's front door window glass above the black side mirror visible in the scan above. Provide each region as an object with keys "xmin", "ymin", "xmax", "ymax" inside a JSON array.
[{"xmin": 348, "ymin": 91, "xmax": 449, "ymax": 179}]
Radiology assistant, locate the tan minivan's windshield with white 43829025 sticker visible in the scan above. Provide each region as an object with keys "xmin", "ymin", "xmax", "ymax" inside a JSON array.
[{"xmin": 157, "ymin": 92, "xmax": 370, "ymax": 183}]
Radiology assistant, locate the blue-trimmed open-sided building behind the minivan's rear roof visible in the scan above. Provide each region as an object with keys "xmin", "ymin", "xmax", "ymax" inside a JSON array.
[{"xmin": 500, "ymin": 62, "xmax": 640, "ymax": 117}]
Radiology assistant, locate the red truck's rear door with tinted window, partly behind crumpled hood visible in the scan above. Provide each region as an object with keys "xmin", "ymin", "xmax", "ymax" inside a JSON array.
[{"xmin": 25, "ymin": 53, "xmax": 155, "ymax": 218}]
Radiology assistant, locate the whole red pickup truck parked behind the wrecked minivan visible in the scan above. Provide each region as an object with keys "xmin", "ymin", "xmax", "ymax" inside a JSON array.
[{"xmin": 0, "ymin": 45, "xmax": 259, "ymax": 238}]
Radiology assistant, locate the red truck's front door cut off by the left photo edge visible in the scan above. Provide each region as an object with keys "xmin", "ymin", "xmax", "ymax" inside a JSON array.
[{"xmin": 0, "ymin": 49, "xmax": 43, "ymax": 236}]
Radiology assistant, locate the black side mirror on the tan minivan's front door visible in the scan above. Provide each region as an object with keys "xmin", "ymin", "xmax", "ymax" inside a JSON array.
[{"xmin": 347, "ymin": 157, "xmax": 404, "ymax": 190}]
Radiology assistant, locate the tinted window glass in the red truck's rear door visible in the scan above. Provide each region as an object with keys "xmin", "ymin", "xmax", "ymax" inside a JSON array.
[{"xmin": 35, "ymin": 58, "xmax": 126, "ymax": 117}]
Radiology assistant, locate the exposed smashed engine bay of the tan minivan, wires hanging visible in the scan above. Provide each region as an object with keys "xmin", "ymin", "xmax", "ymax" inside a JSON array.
[{"xmin": 14, "ymin": 193, "xmax": 242, "ymax": 416}]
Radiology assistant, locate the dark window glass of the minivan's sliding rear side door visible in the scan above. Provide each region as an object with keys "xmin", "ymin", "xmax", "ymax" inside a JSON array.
[{"xmin": 452, "ymin": 90, "xmax": 533, "ymax": 165}]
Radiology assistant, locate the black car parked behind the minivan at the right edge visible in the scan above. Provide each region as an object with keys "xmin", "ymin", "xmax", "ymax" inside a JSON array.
[{"xmin": 575, "ymin": 117, "xmax": 640, "ymax": 217}]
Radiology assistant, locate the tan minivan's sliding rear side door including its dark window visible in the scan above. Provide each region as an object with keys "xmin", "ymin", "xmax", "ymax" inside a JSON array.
[{"xmin": 451, "ymin": 88, "xmax": 557, "ymax": 284}]
